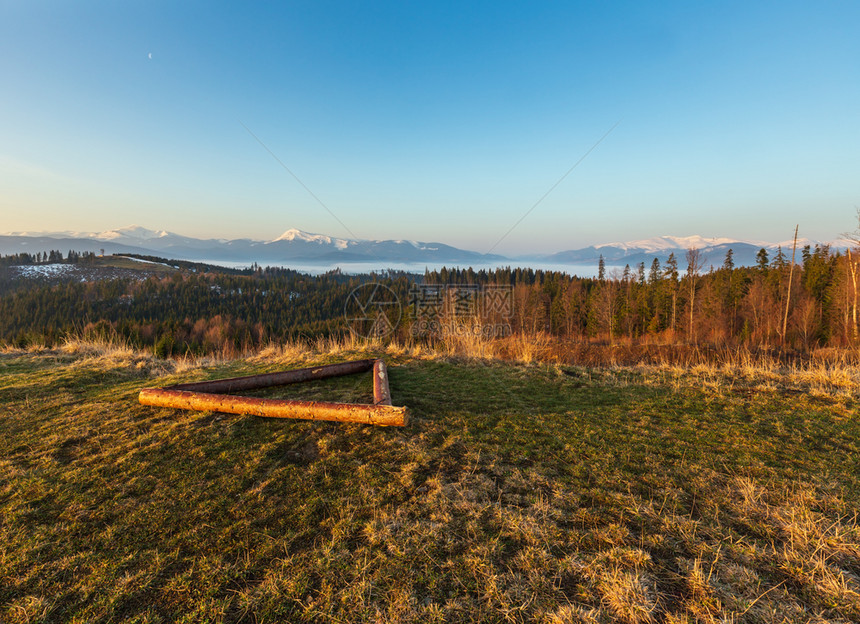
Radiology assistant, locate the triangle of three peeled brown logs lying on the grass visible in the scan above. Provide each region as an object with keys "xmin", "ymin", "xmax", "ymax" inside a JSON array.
[{"xmin": 138, "ymin": 360, "xmax": 409, "ymax": 427}]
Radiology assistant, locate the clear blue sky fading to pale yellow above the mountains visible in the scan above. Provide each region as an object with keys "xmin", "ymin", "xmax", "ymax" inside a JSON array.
[{"xmin": 0, "ymin": 0, "xmax": 860, "ymax": 254}]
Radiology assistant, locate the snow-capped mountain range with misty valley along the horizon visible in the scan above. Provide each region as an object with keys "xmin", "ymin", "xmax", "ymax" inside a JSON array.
[{"xmin": 0, "ymin": 225, "xmax": 845, "ymax": 268}]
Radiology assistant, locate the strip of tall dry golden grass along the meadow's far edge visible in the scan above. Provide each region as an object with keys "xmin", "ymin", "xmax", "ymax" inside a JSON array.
[{"xmin": 6, "ymin": 332, "xmax": 860, "ymax": 400}]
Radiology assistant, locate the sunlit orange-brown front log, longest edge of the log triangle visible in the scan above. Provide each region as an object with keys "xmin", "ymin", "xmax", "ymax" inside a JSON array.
[{"xmin": 138, "ymin": 388, "xmax": 409, "ymax": 427}]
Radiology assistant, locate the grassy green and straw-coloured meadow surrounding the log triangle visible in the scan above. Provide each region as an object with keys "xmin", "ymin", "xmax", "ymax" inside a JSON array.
[{"xmin": 0, "ymin": 341, "xmax": 860, "ymax": 624}]
